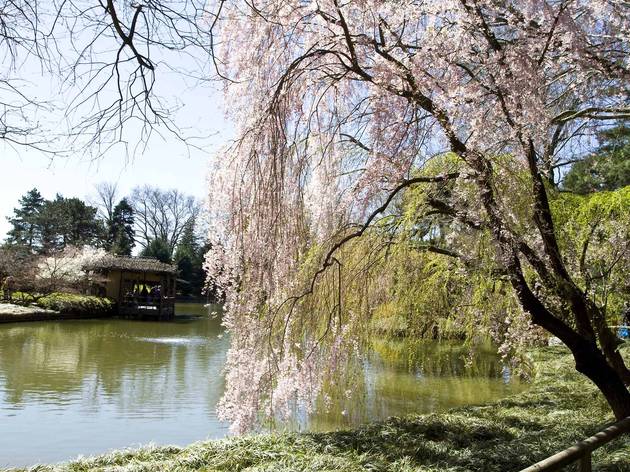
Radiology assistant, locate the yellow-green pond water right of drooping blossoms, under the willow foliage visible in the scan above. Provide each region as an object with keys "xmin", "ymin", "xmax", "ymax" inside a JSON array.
[{"xmin": 300, "ymin": 340, "xmax": 523, "ymax": 431}]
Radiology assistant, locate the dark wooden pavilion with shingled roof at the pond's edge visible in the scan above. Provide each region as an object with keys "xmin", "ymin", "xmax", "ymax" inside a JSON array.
[{"xmin": 84, "ymin": 255, "xmax": 177, "ymax": 320}]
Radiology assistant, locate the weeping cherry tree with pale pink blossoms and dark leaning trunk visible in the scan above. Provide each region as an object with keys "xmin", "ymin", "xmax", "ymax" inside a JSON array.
[{"xmin": 206, "ymin": 0, "xmax": 630, "ymax": 431}]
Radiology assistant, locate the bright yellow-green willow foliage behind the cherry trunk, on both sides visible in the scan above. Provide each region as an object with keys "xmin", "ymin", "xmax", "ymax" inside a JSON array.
[{"xmin": 338, "ymin": 171, "xmax": 630, "ymax": 362}]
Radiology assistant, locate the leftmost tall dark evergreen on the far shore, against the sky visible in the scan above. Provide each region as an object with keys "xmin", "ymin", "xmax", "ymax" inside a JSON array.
[{"xmin": 7, "ymin": 188, "xmax": 44, "ymax": 250}]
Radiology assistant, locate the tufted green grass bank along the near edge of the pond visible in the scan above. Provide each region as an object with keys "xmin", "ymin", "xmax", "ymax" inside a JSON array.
[{"xmin": 6, "ymin": 348, "xmax": 630, "ymax": 472}]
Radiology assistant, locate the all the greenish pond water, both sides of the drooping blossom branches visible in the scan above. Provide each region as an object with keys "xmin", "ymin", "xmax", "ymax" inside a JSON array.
[{"xmin": 0, "ymin": 304, "xmax": 524, "ymax": 467}]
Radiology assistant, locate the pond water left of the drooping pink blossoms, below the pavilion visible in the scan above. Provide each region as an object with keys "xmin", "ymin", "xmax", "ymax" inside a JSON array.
[{"xmin": 0, "ymin": 306, "xmax": 228, "ymax": 467}]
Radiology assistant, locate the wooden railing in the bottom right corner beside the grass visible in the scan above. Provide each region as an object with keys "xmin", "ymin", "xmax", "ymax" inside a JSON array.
[{"xmin": 521, "ymin": 416, "xmax": 630, "ymax": 472}]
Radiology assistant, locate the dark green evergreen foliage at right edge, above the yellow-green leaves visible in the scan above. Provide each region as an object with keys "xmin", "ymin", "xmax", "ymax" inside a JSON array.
[{"xmin": 562, "ymin": 124, "xmax": 630, "ymax": 194}]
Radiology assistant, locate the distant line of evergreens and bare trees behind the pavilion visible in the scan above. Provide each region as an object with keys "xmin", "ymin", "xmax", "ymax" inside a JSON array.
[{"xmin": 0, "ymin": 183, "xmax": 208, "ymax": 296}]
